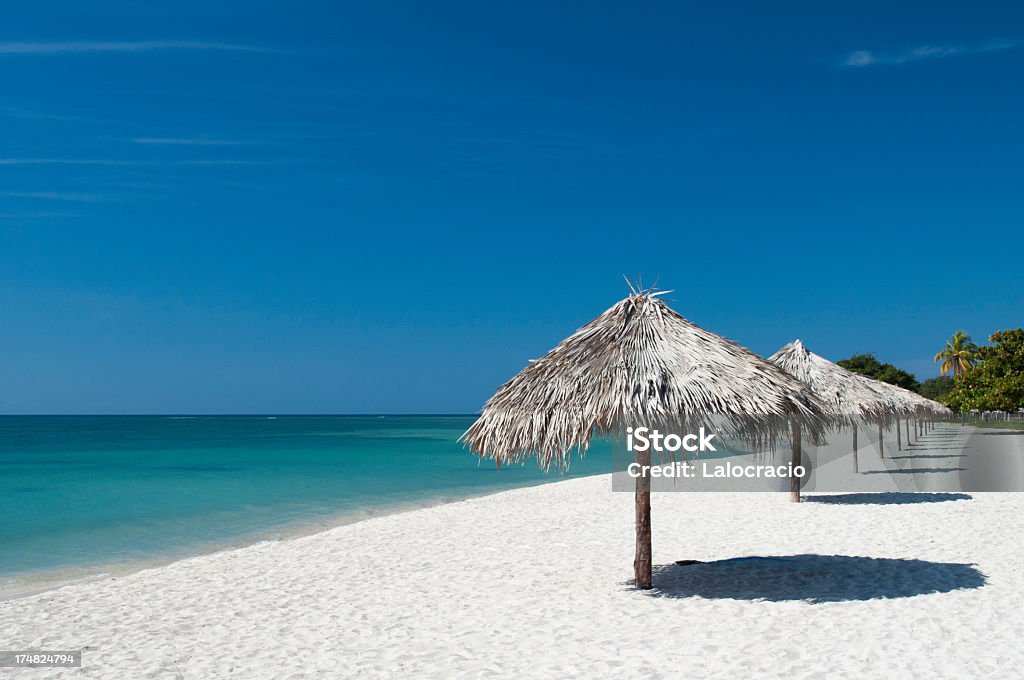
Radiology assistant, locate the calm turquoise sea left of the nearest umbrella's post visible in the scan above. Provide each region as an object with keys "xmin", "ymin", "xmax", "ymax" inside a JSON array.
[{"xmin": 0, "ymin": 416, "xmax": 611, "ymax": 596}]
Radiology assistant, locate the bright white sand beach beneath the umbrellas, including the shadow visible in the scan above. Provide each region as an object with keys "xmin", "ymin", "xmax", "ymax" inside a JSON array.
[{"xmin": 0, "ymin": 426, "xmax": 1024, "ymax": 680}]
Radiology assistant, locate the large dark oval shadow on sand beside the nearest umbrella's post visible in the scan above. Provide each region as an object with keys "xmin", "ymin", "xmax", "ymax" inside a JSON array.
[{"xmin": 650, "ymin": 555, "xmax": 985, "ymax": 604}]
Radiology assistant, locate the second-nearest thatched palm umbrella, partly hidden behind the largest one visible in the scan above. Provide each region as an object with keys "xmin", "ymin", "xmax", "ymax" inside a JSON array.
[{"xmin": 768, "ymin": 340, "xmax": 899, "ymax": 477}]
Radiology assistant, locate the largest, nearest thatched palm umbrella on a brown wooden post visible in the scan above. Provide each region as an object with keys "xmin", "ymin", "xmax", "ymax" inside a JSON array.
[{"xmin": 463, "ymin": 292, "xmax": 826, "ymax": 588}]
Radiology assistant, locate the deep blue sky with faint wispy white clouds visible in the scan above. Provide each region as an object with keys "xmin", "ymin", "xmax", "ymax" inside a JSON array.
[{"xmin": 0, "ymin": 0, "xmax": 1024, "ymax": 414}]
